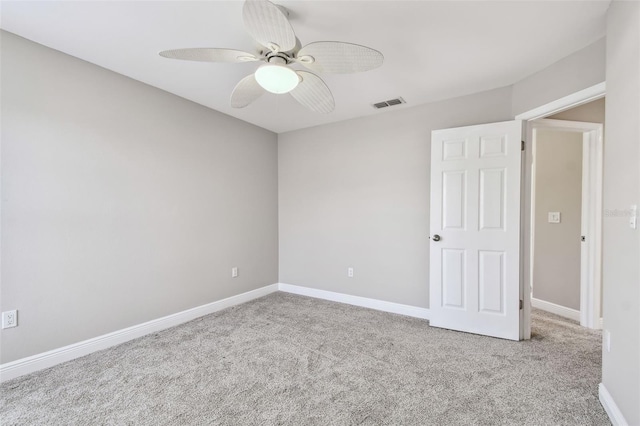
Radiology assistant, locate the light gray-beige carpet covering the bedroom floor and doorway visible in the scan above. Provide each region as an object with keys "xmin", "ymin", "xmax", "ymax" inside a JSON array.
[{"xmin": 0, "ymin": 293, "xmax": 609, "ymax": 425}]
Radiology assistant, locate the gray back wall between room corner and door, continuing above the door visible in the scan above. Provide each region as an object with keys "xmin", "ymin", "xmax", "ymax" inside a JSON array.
[{"xmin": 278, "ymin": 88, "xmax": 511, "ymax": 308}]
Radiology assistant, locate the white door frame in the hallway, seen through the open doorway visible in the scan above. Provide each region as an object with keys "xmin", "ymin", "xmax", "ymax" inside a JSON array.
[{"xmin": 529, "ymin": 119, "xmax": 603, "ymax": 328}]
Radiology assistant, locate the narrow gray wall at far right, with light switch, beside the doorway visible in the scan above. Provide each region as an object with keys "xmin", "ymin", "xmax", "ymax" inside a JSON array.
[{"xmin": 602, "ymin": 0, "xmax": 640, "ymax": 425}]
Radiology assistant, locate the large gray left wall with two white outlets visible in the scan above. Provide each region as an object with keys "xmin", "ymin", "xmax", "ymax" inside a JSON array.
[{"xmin": 0, "ymin": 32, "xmax": 278, "ymax": 363}]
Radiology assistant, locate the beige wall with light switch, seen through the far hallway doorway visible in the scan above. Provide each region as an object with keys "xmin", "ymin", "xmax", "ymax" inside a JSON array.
[{"xmin": 533, "ymin": 129, "xmax": 582, "ymax": 310}]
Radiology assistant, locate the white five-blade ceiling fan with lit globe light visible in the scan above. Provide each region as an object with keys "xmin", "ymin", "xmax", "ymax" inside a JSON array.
[{"xmin": 160, "ymin": 0, "xmax": 384, "ymax": 113}]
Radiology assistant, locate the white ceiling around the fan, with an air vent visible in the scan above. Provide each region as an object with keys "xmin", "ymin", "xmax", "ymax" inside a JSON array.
[{"xmin": 0, "ymin": 0, "xmax": 610, "ymax": 133}]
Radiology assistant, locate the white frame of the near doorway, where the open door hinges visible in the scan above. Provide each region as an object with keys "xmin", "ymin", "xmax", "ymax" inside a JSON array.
[{"xmin": 515, "ymin": 82, "xmax": 606, "ymax": 339}]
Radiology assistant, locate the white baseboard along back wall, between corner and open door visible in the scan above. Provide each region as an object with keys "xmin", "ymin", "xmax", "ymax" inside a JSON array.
[{"xmin": 278, "ymin": 283, "xmax": 429, "ymax": 319}]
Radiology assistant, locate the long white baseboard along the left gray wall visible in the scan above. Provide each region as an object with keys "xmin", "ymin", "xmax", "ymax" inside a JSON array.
[{"xmin": 0, "ymin": 284, "xmax": 278, "ymax": 382}]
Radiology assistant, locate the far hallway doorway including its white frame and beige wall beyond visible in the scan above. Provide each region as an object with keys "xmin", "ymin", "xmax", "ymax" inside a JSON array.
[{"xmin": 530, "ymin": 116, "xmax": 604, "ymax": 328}]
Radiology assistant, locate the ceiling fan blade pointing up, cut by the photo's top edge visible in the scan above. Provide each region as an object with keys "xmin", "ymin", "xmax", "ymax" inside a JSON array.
[{"xmin": 242, "ymin": 0, "xmax": 296, "ymax": 52}]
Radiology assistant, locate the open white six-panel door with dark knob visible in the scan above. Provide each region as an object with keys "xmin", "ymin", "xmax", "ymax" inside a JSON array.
[{"xmin": 429, "ymin": 121, "xmax": 522, "ymax": 340}]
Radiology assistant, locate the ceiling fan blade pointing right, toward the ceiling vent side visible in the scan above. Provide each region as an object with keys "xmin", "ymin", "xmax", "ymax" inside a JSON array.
[{"xmin": 297, "ymin": 41, "xmax": 384, "ymax": 74}]
